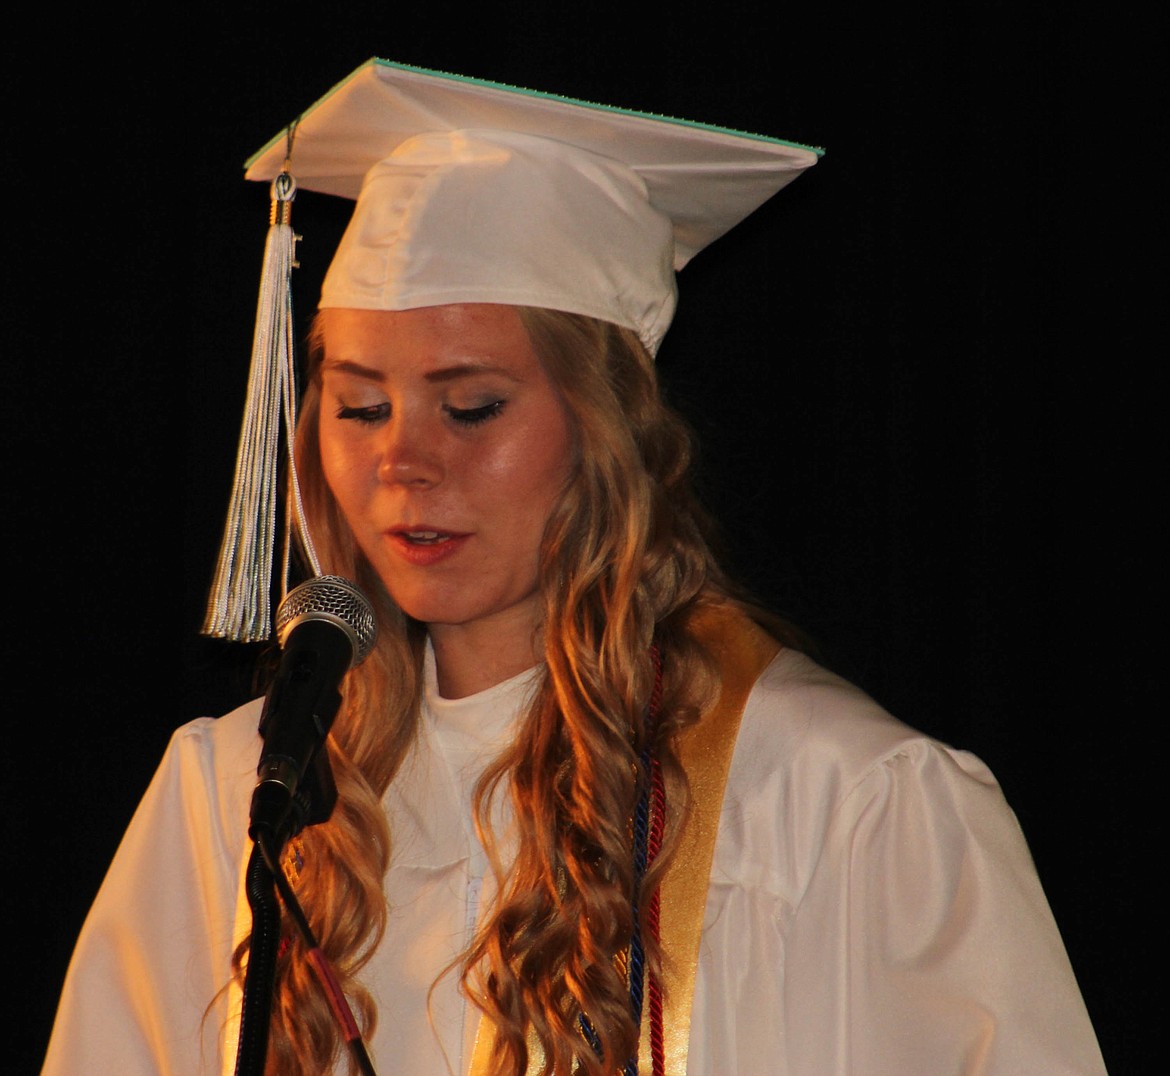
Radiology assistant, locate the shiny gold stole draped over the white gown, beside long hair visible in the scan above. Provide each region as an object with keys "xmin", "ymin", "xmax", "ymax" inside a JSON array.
[{"xmin": 470, "ymin": 606, "xmax": 779, "ymax": 1076}]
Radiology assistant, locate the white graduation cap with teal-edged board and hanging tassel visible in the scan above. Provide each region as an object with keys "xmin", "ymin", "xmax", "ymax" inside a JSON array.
[{"xmin": 204, "ymin": 58, "xmax": 820, "ymax": 637}]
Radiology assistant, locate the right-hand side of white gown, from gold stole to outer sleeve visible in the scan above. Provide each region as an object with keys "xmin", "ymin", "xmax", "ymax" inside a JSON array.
[{"xmin": 687, "ymin": 651, "xmax": 1104, "ymax": 1076}]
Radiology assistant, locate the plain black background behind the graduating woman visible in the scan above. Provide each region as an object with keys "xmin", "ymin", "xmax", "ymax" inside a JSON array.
[{"xmin": 0, "ymin": 0, "xmax": 1164, "ymax": 1076}]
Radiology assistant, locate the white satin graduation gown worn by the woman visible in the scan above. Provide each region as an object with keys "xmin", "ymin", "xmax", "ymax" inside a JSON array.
[{"xmin": 44, "ymin": 650, "xmax": 1104, "ymax": 1076}]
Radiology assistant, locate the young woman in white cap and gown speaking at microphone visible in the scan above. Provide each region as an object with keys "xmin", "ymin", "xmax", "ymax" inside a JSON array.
[{"xmin": 47, "ymin": 64, "xmax": 1103, "ymax": 1076}]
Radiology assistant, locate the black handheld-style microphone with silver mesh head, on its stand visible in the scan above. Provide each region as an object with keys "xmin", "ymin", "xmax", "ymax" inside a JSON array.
[{"xmin": 248, "ymin": 575, "xmax": 378, "ymax": 849}]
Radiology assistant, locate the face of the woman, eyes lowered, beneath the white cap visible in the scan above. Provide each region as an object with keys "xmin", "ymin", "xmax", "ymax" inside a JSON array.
[{"xmin": 321, "ymin": 303, "xmax": 572, "ymax": 646}]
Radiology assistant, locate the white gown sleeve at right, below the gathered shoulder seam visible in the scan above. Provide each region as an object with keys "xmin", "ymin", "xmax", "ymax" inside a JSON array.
[{"xmin": 784, "ymin": 738, "xmax": 1104, "ymax": 1076}]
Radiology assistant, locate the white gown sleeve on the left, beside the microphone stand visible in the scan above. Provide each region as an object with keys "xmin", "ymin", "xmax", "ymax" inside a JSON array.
[{"xmin": 42, "ymin": 705, "xmax": 259, "ymax": 1076}]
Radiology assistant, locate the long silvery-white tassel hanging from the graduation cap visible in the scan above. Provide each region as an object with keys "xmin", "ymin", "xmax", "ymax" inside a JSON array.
[{"xmin": 202, "ymin": 163, "xmax": 306, "ymax": 642}]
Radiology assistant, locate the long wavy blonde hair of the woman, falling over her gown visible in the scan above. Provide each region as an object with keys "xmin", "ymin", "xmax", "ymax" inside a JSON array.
[{"xmin": 236, "ymin": 308, "xmax": 753, "ymax": 1076}]
